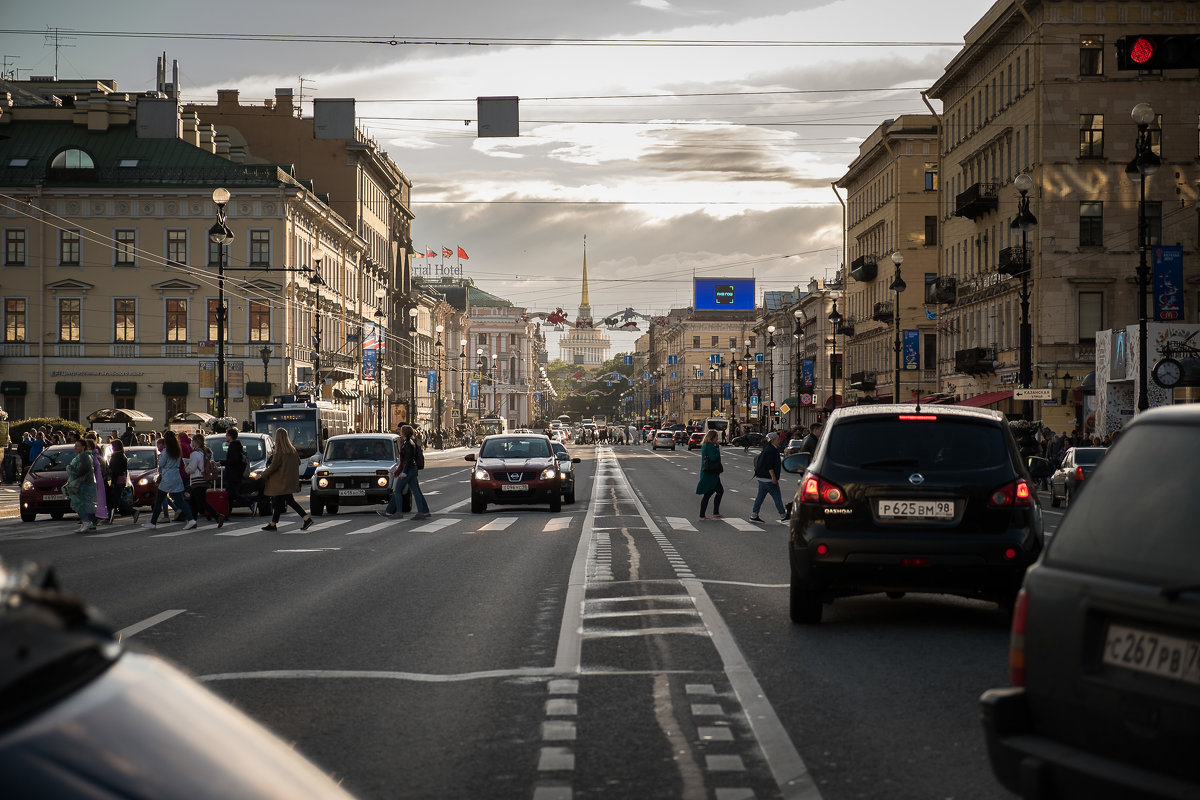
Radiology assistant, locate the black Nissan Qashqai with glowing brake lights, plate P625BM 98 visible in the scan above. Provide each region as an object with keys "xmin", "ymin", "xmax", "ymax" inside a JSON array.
[{"xmin": 784, "ymin": 404, "xmax": 1050, "ymax": 624}]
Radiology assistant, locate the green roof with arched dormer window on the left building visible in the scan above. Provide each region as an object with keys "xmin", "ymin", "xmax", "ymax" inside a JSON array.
[{"xmin": 0, "ymin": 120, "xmax": 286, "ymax": 187}]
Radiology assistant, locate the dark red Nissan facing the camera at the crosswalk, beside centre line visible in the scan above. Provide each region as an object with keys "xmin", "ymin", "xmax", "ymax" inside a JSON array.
[{"xmin": 466, "ymin": 433, "xmax": 563, "ymax": 513}]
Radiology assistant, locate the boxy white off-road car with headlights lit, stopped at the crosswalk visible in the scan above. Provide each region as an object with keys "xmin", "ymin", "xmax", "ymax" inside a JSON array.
[{"xmin": 308, "ymin": 433, "xmax": 403, "ymax": 517}]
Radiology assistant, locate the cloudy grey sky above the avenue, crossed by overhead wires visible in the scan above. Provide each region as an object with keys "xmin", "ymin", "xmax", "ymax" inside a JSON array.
[{"xmin": 0, "ymin": 0, "xmax": 991, "ymax": 335}]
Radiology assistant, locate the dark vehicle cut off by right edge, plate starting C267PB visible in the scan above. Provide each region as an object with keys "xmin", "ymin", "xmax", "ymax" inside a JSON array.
[{"xmin": 980, "ymin": 404, "xmax": 1200, "ymax": 800}]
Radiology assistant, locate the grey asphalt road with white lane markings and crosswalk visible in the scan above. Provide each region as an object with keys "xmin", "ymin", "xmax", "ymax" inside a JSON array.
[{"xmin": 0, "ymin": 447, "xmax": 1060, "ymax": 800}]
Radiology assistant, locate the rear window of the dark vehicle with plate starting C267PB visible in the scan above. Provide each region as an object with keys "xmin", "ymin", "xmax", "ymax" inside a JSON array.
[{"xmin": 1045, "ymin": 422, "xmax": 1200, "ymax": 583}]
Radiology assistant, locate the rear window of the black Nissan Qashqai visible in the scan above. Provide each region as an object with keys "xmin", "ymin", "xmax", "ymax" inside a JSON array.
[{"xmin": 824, "ymin": 416, "xmax": 1010, "ymax": 471}]
